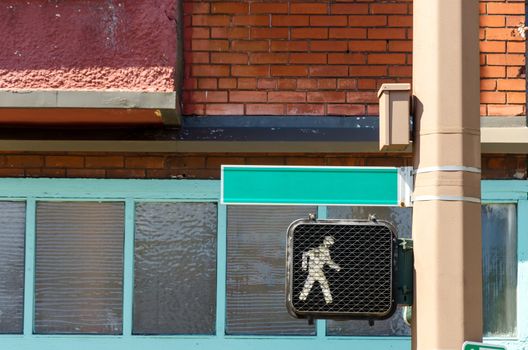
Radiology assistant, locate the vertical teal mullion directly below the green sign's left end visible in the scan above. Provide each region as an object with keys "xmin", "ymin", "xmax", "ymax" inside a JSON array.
[{"xmin": 216, "ymin": 204, "xmax": 227, "ymax": 338}]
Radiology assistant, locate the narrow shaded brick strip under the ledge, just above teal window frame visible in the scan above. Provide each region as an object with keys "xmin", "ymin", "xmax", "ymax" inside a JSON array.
[{"xmin": 0, "ymin": 153, "xmax": 528, "ymax": 179}]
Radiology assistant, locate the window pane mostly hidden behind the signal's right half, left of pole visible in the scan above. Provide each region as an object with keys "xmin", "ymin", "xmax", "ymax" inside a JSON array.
[{"xmin": 327, "ymin": 207, "xmax": 412, "ymax": 336}]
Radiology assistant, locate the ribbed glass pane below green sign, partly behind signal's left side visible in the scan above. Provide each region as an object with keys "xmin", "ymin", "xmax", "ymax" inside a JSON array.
[{"xmin": 227, "ymin": 206, "xmax": 317, "ymax": 335}]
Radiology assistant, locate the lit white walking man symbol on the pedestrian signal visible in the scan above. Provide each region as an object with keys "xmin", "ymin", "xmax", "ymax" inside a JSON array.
[{"xmin": 299, "ymin": 236, "xmax": 341, "ymax": 304}]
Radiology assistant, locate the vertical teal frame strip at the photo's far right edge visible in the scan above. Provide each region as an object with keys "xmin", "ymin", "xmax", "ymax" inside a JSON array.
[{"xmin": 517, "ymin": 200, "xmax": 528, "ymax": 342}]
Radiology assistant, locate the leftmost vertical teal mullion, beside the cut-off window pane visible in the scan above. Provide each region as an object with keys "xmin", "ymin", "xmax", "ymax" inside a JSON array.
[{"xmin": 24, "ymin": 198, "xmax": 37, "ymax": 336}]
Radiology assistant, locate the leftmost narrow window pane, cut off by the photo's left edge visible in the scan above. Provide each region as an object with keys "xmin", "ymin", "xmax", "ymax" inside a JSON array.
[{"xmin": 0, "ymin": 202, "xmax": 26, "ymax": 333}]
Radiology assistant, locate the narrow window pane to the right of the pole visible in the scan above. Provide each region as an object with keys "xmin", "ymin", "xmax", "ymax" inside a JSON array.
[{"xmin": 482, "ymin": 204, "xmax": 517, "ymax": 336}]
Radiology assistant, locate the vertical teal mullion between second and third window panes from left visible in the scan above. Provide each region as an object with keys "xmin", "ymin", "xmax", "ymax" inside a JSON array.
[{"xmin": 123, "ymin": 199, "xmax": 135, "ymax": 336}]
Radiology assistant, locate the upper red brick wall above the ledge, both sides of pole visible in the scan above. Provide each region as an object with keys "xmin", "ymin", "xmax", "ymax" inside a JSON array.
[{"xmin": 184, "ymin": 0, "xmax": 525, "ymax": 115}]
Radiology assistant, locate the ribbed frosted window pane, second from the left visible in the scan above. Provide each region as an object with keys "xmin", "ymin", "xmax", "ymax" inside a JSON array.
[{"xmin": 35, "ymin": 202, "xmax": 124, "ymax": 334}]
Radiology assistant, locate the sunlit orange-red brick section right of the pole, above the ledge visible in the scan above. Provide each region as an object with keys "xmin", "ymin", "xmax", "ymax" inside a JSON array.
[{"xmin": 480, "ymin": 0, "xmax": 528, "ymax": 115}]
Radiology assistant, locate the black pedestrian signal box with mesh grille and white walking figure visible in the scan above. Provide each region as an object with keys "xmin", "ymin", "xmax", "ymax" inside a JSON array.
[{"xmin": 289, "ymin": 222, "xmax": 394, "ymax": 318}]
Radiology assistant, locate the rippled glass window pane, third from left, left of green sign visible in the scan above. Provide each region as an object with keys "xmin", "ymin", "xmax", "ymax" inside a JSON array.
[{"xmin": 134, "ymin": 203, "xmax": 217, "ymax": 334}]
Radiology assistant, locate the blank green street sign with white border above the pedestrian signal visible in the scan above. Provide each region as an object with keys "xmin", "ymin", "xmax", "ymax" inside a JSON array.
[{"xmin": 221, "ymin": 165, "xmax": 411, "ymax": 206}]
